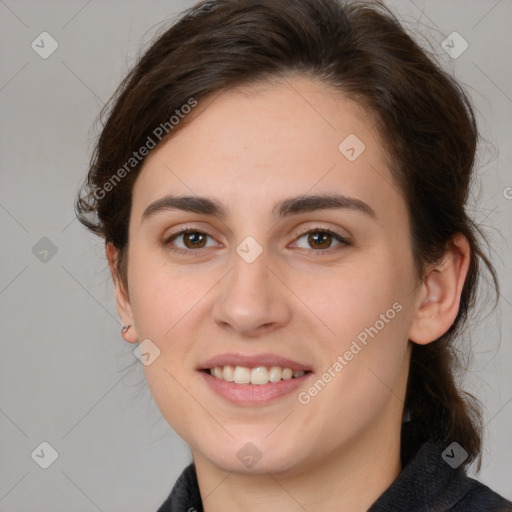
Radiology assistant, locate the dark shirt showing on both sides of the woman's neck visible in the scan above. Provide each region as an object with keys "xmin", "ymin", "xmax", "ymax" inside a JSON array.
[{"xmin": 157, "ymin": 426, "xmax": 512, "ymax": 512}]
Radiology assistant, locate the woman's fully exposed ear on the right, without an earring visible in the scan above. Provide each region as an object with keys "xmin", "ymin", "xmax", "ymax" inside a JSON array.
[{"xmin": 409, "ymin": 233, "xmax": 471, "ymax": 345}]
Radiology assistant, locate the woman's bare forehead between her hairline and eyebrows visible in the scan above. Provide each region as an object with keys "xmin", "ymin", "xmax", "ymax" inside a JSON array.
[{"xmin": 133, "ymin": 78, "xmax": 405, "ymax": 226}]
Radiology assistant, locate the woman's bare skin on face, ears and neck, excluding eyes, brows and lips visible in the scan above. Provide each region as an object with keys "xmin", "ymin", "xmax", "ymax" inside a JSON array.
[{"xmin": 107, "ymin": 76, "xmax": 469, "ymax": 512}]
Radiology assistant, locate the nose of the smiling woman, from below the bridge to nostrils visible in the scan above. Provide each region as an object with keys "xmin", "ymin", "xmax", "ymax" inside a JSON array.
[{"xmin": 213, "ymin": 247, "xmax": 293, "ymax": 338}]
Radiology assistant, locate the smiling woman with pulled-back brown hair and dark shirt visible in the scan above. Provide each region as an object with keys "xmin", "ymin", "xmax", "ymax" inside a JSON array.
[{"xmin": 77, "ymin": 0, "xmax": 512, "ymax": 512}]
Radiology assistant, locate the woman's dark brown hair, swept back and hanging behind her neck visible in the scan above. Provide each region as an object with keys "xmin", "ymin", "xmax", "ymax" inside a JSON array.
[{"xmin": 75, "ymin": 0, "xmax": 499, "ymax": 467}]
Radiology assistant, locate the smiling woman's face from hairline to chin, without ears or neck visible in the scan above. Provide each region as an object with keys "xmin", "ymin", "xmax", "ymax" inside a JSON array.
[{"xmin": 118, "ymin": 78, "xmax": 422, "ymax": 473}]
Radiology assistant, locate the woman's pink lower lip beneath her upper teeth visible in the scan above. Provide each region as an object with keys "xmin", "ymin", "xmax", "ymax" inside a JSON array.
[{"xmin": 200, "ymin": 371, "xmax": 313, "ymax": 406}]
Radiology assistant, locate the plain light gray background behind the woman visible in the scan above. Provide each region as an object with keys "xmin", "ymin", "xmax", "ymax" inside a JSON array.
[{"xmin": 0, "ymin": 0, "xmax": 512, "ymax": 512}]
